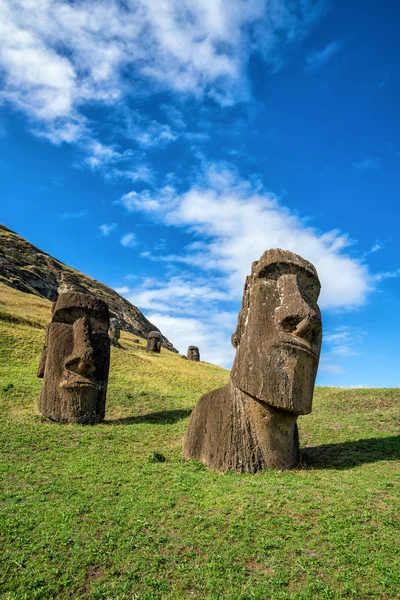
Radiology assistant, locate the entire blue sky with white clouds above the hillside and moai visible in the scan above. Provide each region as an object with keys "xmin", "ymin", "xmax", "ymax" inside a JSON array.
[{"xmin": 0, "ymin": 0, "xmax": 400, "ymax": 387}]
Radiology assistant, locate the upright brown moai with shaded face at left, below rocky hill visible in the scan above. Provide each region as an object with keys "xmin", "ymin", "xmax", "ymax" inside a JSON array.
[{"xmin": 37, "ymin": 292, "xmax": 110, "ymax": 423}]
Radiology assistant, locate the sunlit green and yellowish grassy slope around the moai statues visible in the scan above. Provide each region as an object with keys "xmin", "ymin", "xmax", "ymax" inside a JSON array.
[{"xmin": 0, "ymin": 285, "xmax": 400, "ymax": 600}]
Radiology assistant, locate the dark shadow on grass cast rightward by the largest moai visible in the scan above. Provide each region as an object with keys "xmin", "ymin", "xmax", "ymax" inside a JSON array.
[{"xmin": 301, "ymin": 435, "xmax": 400, "ymax": 469}]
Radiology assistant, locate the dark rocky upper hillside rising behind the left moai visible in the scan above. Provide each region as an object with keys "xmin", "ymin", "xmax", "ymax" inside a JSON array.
[{"xmin": 0, "ymin": 225, "xmax": 177, "ymax": 352}]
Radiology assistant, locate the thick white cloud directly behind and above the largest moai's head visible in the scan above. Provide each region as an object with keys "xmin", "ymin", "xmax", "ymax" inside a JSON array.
[{"xmin": 121, "ymin": 164, "xmax": 371, "ymax": 309}]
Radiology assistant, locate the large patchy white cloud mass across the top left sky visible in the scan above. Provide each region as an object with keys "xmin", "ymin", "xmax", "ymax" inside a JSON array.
[{"xmin": 0, "ymin": 0, "xmax": 325, "ymax": 145}]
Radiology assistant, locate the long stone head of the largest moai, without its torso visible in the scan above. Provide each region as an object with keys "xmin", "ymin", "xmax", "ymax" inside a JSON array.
[{"xmin": 231, "ymin": 249, "xmax": 322, "ymax": 414}]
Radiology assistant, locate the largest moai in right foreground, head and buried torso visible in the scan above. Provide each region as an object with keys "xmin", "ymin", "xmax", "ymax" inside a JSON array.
[{"xmin": 183, "ymin": 249, "xmax": 322, "ymax": 472}]
